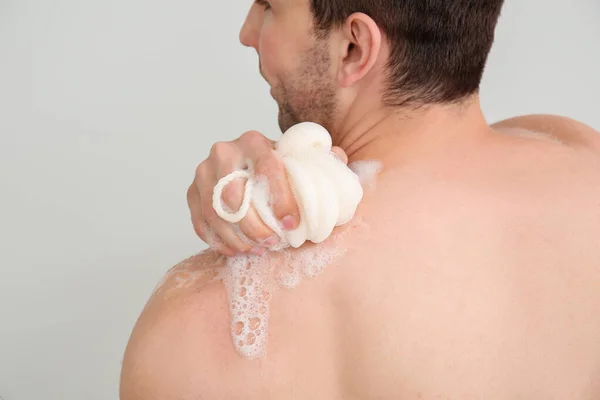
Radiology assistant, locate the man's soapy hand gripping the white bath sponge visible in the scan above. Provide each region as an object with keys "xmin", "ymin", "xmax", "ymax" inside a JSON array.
[{"xmin": 187, "ymin": 131, "xmax": 348, "ymax": 257}]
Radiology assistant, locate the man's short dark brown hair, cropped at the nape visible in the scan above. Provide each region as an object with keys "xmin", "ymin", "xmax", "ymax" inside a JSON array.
[{"xmin": 310, "ymin": 0, "xmax": 504, "ymax": 106}]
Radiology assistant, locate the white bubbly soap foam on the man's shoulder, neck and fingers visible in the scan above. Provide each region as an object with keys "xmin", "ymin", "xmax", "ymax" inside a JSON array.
[{"xmin": 156, "ymin": 161, "xmax": 381, "ymax": 359}]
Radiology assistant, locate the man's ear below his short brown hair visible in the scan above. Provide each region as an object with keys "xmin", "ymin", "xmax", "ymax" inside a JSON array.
[{"xmin": 337, "ymin": 13, "xmax": 382, "ymax": 87}]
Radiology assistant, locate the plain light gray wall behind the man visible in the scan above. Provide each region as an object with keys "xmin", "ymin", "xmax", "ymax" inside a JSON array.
[{"xmin": 0, "ymin": 0, "xmax": 600, "ymax": 400}]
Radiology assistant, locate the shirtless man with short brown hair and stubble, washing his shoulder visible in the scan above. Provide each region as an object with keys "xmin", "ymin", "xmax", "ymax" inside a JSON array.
[{"xmin": 121, "ymin": 0, "xmax": 600, "ymax": 400}]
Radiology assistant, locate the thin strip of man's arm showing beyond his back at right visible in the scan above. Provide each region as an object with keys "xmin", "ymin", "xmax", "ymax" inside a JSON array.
[{"xmin": 492, "ymin": 114, "xmax": 600, "ymax": 156}]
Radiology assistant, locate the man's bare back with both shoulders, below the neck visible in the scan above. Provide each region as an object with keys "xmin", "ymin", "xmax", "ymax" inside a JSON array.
[{"xmin": 121, "ymin": 117, "xmax": 600, "ymax": 400}]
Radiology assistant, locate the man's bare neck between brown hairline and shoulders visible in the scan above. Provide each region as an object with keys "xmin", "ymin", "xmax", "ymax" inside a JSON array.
[{"xmin": 332, "ymin": 96, "xmax": 490, "ymax": 163}]
